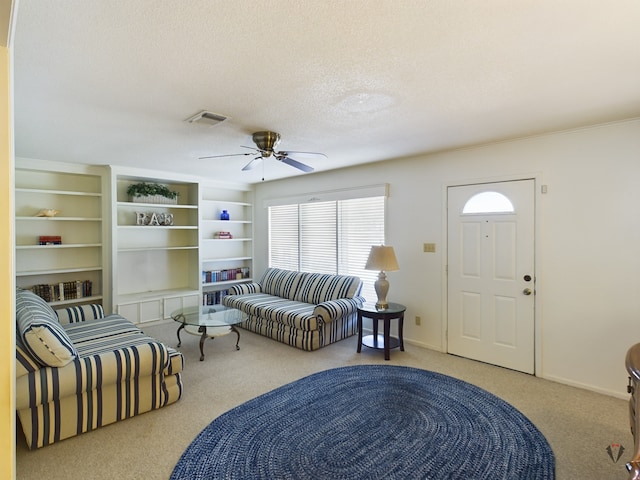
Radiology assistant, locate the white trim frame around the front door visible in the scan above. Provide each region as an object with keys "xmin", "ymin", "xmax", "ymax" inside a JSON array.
[{"xmin": 440, "ymin": 173, "xmax": 547, "ymax": 377}]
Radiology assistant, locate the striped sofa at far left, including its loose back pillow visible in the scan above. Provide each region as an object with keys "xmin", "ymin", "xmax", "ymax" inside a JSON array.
[{"xmin": 15, "ymin": 290, "xmax": 183, "ymax": 449}]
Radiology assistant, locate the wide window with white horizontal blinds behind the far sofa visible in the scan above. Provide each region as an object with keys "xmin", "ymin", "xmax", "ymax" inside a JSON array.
[{"xmin": 269, "ymin": 196, "xmax": 385, "ymax": 301}]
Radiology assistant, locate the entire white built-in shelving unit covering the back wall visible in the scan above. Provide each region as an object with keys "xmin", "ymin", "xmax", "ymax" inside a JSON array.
[{"xmin": 15, "ymin": 159, "xmax": 253, "ymax": 323}]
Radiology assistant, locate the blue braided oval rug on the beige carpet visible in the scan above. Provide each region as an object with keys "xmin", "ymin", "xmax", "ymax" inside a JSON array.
[{"xmin": 171, "ymin": 365, "xmax": 555, "ymax": 480}]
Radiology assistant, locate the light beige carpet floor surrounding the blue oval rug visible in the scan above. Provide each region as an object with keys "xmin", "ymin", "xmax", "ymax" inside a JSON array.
[{"xmin": 16, "ymin": 323, "xmax": 633, "ymax": 480}]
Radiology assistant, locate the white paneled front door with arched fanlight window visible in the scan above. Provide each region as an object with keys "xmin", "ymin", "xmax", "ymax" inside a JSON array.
[{"xmin": 447, "ymin": 180, "xmax": 535, "ymax": 374}]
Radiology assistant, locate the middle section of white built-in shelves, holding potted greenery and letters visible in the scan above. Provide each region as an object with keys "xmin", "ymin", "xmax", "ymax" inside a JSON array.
[{"xmin": 111, "ymin": 168, "xmax": 200, "ymax": 323}]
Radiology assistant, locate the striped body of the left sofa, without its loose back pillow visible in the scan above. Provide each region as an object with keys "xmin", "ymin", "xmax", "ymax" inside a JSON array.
[{"xmin": 16, "ymin": 315, "xmax": 183, "ymax": 449}]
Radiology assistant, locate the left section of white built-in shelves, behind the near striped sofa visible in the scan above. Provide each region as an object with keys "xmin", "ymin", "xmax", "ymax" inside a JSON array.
[{"xmin": 15, "ymin": 158, "xmax": 109, "ymax": 308}]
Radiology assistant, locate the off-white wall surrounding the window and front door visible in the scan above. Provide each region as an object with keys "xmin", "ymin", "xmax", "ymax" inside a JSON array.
[{"xmin": 254, "ymin": 119, "xmax": 640, "ymax": 398}]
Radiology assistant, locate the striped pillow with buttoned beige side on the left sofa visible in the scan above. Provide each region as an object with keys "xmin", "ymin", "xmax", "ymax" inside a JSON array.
[{"xmin": 16, "ymin": 289, "xmax": 78, "ymax": 367}]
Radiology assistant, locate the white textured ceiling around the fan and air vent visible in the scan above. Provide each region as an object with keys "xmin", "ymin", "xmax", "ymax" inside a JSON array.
[{"xmin": 14, "ymin": 0, "xmax": 640, "ymax": 183}]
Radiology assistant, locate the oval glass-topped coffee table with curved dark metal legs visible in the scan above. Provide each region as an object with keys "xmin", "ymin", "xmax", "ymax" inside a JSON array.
[{"xmin": 171, "ymin": 305, "xmax": 243, "ymax": 361}]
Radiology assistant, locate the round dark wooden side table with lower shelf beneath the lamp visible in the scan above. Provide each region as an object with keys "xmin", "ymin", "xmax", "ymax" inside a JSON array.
[{"xmin": 358, "ymin": 303, "xmax": 407, "ymax": 360}]
